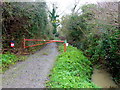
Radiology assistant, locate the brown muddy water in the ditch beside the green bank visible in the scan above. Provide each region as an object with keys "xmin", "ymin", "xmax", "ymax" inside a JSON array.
[{"xmin": 92, "ymin": 67, "xmax": 118, "ymax": 88}]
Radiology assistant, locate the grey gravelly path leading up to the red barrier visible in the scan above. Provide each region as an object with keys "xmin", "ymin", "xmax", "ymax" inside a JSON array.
[{"xmin": 2, "ymin": 43, "xmax": 59, "ymax": 88}]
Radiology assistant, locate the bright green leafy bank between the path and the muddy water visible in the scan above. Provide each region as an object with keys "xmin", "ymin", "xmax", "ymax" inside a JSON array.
[{"xmin": 46, "ymin": 45, "xmax": 98, "ymax": 88}]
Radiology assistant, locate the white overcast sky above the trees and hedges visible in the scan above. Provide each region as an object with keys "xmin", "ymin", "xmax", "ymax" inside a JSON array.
[{"xmin": 45, "ymin": 0, "xmax": 120, "ymax": 15}]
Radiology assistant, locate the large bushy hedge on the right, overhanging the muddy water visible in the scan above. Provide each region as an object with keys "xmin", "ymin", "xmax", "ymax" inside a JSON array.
[{"xmin": 60, "ymin": 2, "xmax": 120, "ymax": 83}]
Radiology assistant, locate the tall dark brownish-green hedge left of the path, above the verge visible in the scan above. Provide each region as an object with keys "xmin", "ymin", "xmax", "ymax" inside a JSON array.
[{"xmin": 2, "ymin": 2, "xmax": 52, "ymax": 52}]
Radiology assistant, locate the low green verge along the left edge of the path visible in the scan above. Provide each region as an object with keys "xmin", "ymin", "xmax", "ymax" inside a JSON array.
[{"xmin": 0, "ymin": 45, "xmax": 46, "ymax": 73}]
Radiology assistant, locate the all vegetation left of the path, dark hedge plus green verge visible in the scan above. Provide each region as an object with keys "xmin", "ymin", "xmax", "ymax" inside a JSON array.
[{"xmin": 0, "ymin": 2, "xmax": 52, "ymax": 71}]
